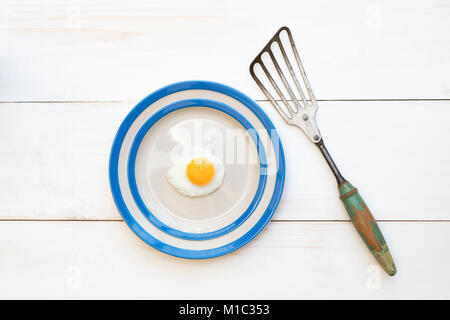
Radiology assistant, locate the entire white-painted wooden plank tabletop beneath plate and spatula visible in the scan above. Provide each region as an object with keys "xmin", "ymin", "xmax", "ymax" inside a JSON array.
[{"xmin": 0, "ymin": 0, "xmax": 450, "ymax": 299}]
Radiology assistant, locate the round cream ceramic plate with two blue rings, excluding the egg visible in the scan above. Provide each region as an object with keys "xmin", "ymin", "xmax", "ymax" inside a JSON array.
[{"xmin": 109, "ymin": 81, "xmax": 284, "ymax": 258}]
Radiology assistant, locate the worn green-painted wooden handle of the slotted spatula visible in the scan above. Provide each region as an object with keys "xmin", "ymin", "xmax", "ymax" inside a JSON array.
[{"xmin": 339, "ymin": 181, "xmax": 397, "ymax": 276}]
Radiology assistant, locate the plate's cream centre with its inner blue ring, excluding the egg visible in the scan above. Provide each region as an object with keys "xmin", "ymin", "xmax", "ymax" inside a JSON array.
[{"xmin": 128, "ymin": 99, "xmax": 267, "ymax": 240}]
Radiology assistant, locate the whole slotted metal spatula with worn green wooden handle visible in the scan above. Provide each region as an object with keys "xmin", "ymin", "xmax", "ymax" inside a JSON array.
[{"xmin": 250, "ymin": 27, "xmax": 397, "ymax": 276}]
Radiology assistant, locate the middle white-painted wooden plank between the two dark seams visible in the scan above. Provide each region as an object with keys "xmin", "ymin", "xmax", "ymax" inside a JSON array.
[{"xmin": 0, "ymin": 101, "xmax": 450, "ymax": 220}]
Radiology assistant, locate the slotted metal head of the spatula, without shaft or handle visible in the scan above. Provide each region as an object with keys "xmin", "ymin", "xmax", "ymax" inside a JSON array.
[{"xmin": 250, "ymin": 27, "xmax": 321, "ymax": 143}]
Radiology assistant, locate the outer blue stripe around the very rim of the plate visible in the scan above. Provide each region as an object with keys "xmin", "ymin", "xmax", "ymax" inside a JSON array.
[{"xmin": 109, "ymin": 81, "xmax": 285, "ymax": 259}]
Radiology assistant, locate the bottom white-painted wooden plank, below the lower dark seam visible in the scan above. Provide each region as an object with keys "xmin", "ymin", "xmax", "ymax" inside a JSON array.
[{"xmin": 0, "ymin": 221, "xmax": 450, "ymax": 299}]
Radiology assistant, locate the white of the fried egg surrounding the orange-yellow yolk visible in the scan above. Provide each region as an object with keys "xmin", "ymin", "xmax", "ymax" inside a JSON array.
[{"xmin": 167, "ymin": 151, "xmax": 225, "ymax": 197}]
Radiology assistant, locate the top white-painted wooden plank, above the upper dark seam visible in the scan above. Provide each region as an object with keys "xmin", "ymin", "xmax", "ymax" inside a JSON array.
[{"xmin": 0, "ymin": 0, "xmax": 450, "ymax": 101}]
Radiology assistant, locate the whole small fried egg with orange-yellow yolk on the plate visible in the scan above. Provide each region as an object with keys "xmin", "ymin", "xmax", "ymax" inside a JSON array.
[{"xmin": 167, "ymin": 151, "xmax": 225, "ymax": 197}]
